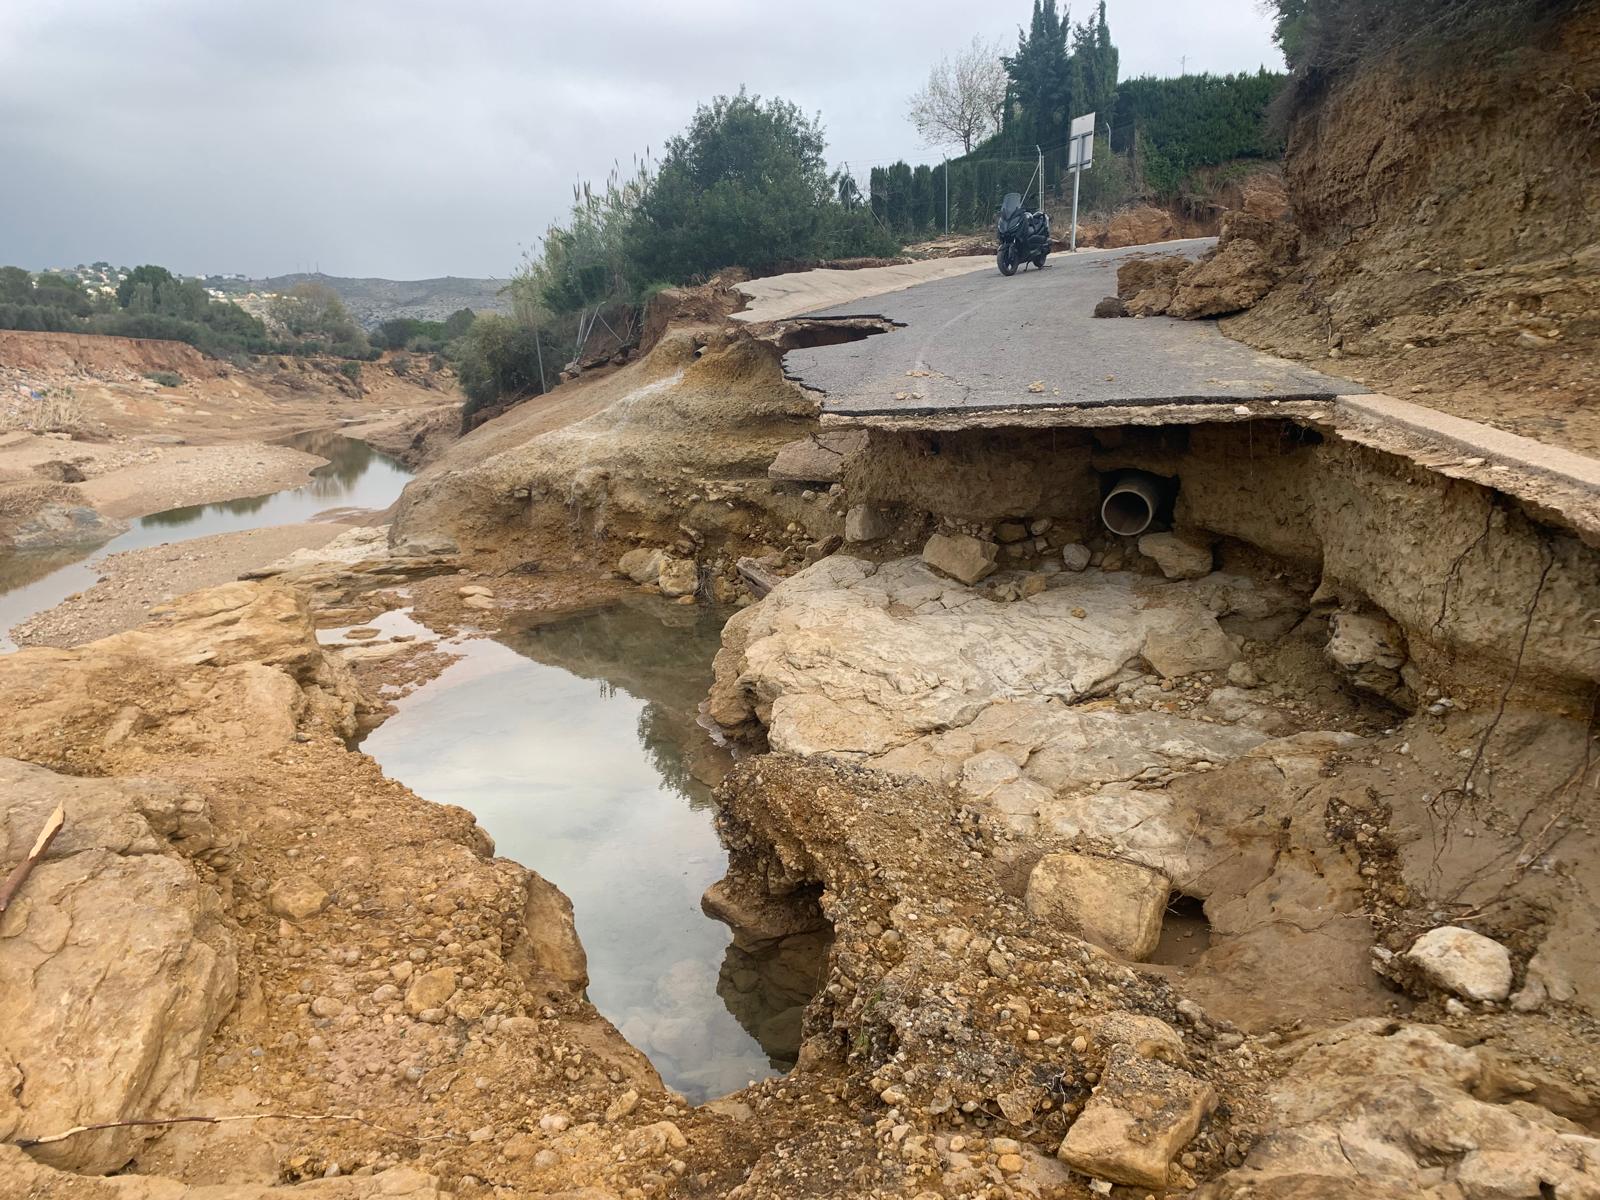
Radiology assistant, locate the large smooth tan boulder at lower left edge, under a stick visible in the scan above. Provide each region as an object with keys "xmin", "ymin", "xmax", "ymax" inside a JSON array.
[{"xmin": 0, "ymin": 762, "xmax": 238, "ymax": 1173}]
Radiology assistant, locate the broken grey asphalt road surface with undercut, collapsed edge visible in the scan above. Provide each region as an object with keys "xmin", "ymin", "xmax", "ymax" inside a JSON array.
[{"xmin": 784, "ymin": 238, "xmax": 1363, "ymax": 418}]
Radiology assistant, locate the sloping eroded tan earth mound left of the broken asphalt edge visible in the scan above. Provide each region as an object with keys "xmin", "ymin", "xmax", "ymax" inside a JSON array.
[{"xmin": 395, "ymin": 330, "xmax": 843, "ymax": 598}]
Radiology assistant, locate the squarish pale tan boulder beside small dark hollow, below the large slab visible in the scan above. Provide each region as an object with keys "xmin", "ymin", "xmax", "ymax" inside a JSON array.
[{"xmin": 1024, "ymin": 853, "xmax": 1173, "ymax": 962}]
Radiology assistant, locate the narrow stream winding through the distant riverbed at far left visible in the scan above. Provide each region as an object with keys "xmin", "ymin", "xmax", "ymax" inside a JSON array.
[{"xmin": 0, "ymin": 430, "xmax": 411, "ymax": 653}]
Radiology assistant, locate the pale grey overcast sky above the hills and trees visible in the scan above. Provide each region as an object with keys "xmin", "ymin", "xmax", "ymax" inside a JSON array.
[{"xmin": 0, "ymin": 0, "xmax": 1283, "ymax": 278}]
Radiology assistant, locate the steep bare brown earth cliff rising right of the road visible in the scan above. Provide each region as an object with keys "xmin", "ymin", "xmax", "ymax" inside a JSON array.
[{"xmin": 1226, "ymin": 5, "xmax": 1600, "ymax": 453}]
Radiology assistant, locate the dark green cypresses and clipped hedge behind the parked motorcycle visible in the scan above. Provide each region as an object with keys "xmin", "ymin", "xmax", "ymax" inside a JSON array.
[{"xmin": 869, "ymin": 0, "xmax": 1299, "ymax": 238}]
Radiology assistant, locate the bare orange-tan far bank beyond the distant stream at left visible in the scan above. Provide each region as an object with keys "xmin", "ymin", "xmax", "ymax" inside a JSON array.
[{"xmin": 0, "ymin": 331, "xmax": 459, "ymax": 549}]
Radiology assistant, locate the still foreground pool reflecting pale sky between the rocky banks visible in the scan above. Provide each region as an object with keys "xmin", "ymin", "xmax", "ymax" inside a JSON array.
[{"xmin": 362, "ymin": 597, "xmax": 821, "ymax": 1101}]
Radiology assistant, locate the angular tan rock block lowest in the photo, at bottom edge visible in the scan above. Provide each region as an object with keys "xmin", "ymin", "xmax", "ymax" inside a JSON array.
[{"xmin": 1056, "ymin": 1045, "xmax": 1216, "ymax": 1189}]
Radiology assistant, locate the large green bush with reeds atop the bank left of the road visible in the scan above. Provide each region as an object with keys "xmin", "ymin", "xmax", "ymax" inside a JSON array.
[{"xmin": 454, "ymin": 91, "xmax": 899, "ymax": 421}]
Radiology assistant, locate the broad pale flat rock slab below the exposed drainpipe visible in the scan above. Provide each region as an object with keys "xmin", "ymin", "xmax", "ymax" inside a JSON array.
[{"xmin": 709, "ymin": 554, "xmax": 1262, "ymax": 774}]
